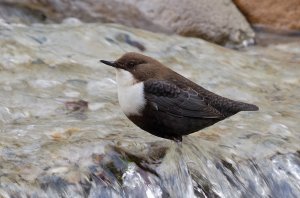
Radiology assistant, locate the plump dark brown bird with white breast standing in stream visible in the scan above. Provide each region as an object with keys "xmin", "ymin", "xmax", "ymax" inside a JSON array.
[{"xmin": 101, "ymin": 52, "xmax": 258, "ymax": 141}]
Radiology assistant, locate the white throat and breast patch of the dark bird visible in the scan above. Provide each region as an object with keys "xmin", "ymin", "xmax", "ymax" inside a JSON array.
[{"xmin": 116, "ymin": 69, "xmax": 146, "ymax": 116}]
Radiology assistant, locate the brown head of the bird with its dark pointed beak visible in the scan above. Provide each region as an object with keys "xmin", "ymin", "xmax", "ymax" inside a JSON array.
[{"xmin": 101, "ymin": 52, "xmax": 169, "ymax": 82}]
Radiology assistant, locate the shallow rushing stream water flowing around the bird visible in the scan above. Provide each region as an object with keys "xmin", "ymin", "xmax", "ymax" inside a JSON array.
[{"xmin": 0, "ymin": 20, "xmax": 300, "ymax": 198}]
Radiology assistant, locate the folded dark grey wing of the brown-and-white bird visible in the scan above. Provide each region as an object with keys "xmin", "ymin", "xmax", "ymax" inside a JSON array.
[{"xmin": 144, "ymin": 80, "xmax": 224, "ymax": 118}]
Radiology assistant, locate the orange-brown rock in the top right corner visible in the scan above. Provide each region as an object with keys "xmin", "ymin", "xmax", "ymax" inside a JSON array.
[{"xmin": 234, "ymin": 0, "xmax": 300, "ymax": 30}]
